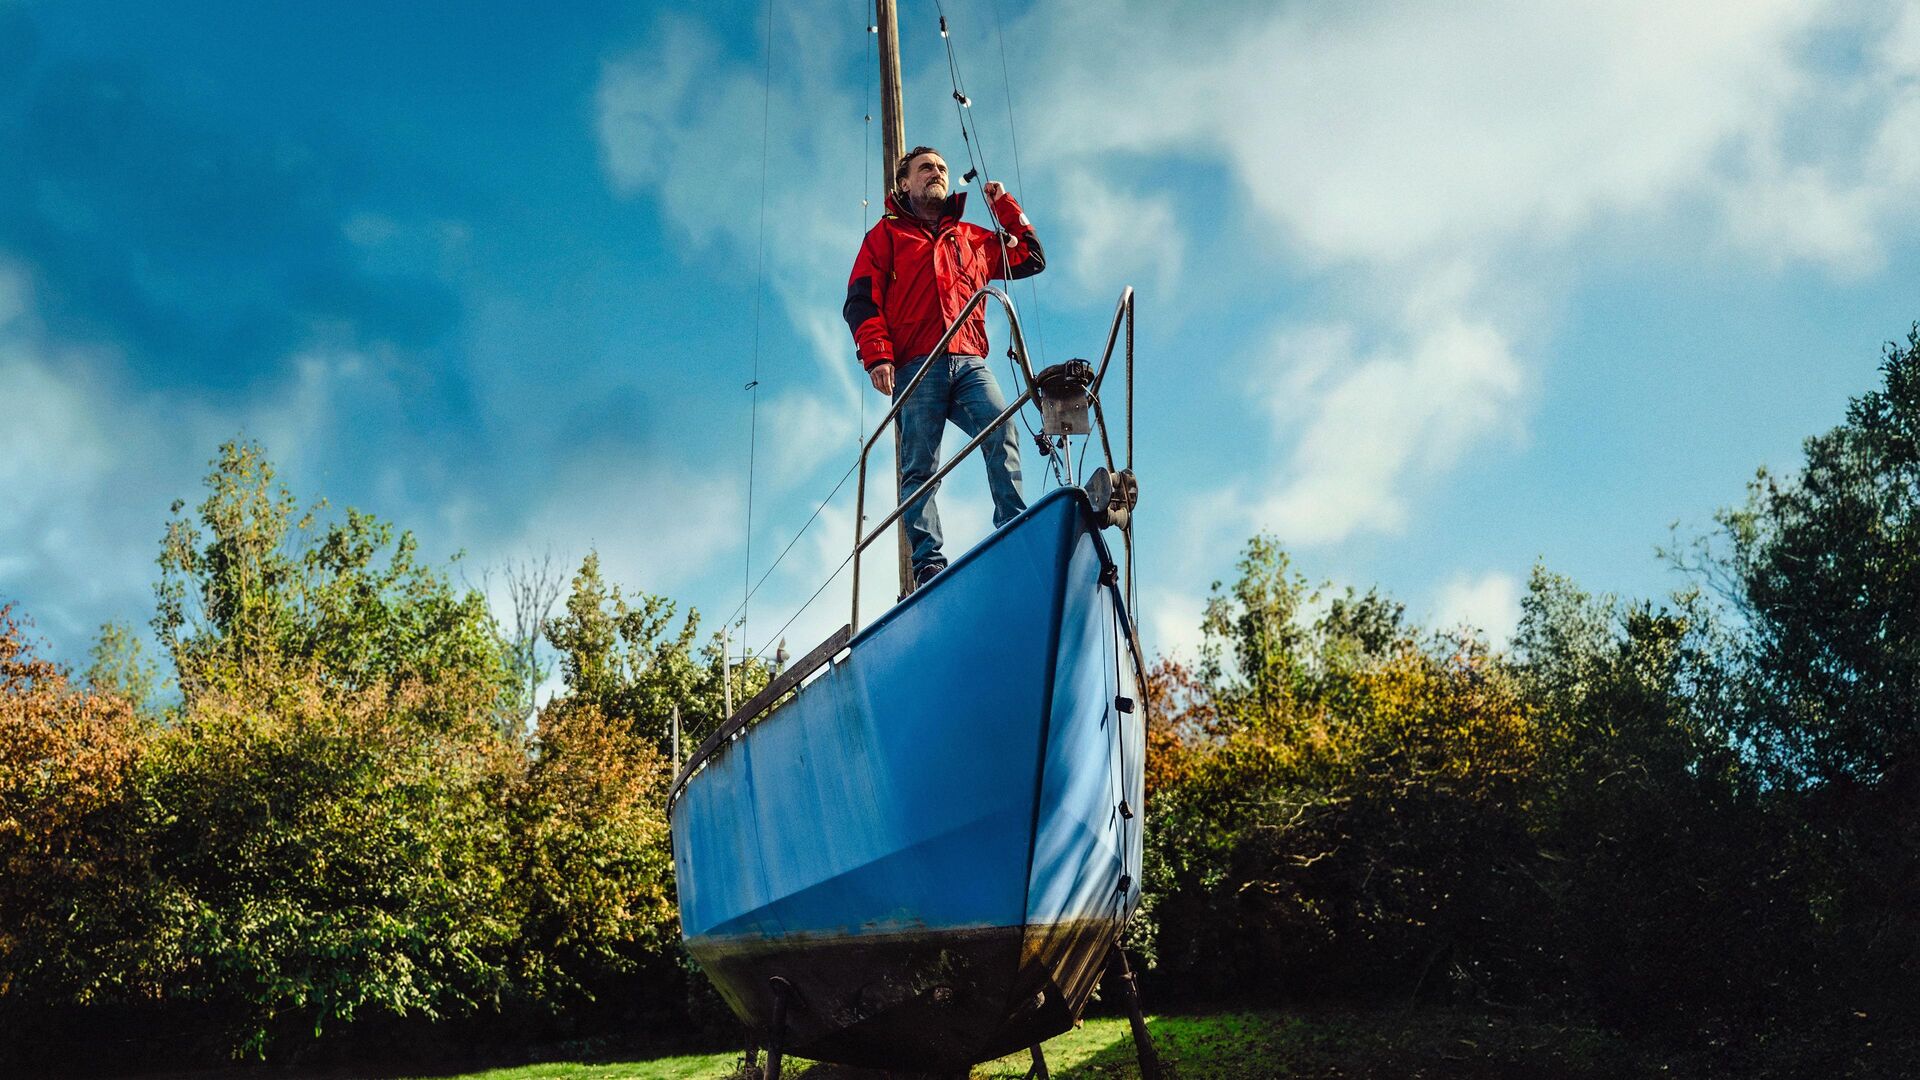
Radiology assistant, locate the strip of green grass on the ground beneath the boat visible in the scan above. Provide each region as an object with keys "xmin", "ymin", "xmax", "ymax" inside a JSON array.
[{"xmin": 416, "ymin": 1011, "xmax": 1659, "ymax": 1080}]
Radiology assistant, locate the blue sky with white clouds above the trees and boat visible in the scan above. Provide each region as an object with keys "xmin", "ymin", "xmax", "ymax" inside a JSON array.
[{"xmin": 0, "ymin": 0, "xmax": 1920, "ymax": 663}]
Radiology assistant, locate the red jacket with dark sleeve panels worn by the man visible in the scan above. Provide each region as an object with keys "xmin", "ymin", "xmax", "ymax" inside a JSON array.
[{"xmin": 841, "ymin": 192, "xmax": 1046, "ymax": 369}]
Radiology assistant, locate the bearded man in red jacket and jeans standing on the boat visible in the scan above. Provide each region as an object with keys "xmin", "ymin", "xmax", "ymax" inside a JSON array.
[{"xmin": 841, "ymin": 146, "xmax": 1046, "ymax": 586}]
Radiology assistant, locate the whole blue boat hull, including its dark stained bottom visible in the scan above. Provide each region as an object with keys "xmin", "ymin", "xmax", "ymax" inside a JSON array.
[{"xmin": 672, "ymin": 488, "xmax": 1144, "ymax": 1068}]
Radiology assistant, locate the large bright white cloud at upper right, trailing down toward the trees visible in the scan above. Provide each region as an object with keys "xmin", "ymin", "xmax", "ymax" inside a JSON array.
[{"xmin": 1018, "ymin": 0, "xmax": 1920, "ymax": 544}]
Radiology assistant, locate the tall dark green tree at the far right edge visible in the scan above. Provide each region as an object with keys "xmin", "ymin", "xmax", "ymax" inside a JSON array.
[{"xmin": 1689, "ymin": 325, "xmax": 1920, "ymax": 1045}]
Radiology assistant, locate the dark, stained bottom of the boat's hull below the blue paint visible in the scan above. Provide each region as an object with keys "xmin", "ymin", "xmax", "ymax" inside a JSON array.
[{"xmin": 687, "ymin": 919, "xmax": 1117, "ymax": 1070}]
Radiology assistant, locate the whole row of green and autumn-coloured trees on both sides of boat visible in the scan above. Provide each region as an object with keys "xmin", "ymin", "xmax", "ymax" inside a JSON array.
[{"xmin": 22, "ymin": 315, "xmax": 1920, "ymax": 1074}]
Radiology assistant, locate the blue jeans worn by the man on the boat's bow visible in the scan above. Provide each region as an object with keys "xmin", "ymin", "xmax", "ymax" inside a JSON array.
[{"xmin": 893, "ymin": 356, "xmax": 1027, "ymax": 573}]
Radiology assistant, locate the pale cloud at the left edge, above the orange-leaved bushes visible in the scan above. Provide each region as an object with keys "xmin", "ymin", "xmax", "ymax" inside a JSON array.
[{"xmin": 0, "ymin": 258, "xmax": 510, "ymax": 661}]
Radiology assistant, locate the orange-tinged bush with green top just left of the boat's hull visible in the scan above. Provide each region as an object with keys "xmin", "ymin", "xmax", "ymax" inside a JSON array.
[{"xmin": 520, "ymin": 553, "xmax": 770, "ymax": 1026}]
